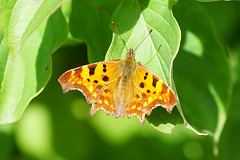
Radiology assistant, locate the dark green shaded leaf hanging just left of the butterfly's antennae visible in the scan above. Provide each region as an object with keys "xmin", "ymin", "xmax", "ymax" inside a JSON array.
[{"xmin": 69, "ymin": 0, "xmax": 120, "ymax": 62}]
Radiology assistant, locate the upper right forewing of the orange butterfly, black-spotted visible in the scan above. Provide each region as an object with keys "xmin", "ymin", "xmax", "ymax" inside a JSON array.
[{"xmin": 134, "ymin": 63, "xmax": 177, "ymax": 115}]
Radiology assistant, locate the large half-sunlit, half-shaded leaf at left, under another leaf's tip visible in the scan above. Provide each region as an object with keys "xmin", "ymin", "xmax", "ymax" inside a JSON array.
[{"xmin": 0, "ymin": 10, "xmax": 68, "ymax": 124}]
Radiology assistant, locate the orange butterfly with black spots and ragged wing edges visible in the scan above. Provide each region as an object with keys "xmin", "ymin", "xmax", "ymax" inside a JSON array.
[{"xmin": 58, "ymin": 23, "xmax": 177, "ymax": 125}]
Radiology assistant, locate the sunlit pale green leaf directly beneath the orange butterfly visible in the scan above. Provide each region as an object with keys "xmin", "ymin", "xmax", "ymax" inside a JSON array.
[{"xmin": 106, "ymin": 0, "xmax": 183, "ymax": 133}]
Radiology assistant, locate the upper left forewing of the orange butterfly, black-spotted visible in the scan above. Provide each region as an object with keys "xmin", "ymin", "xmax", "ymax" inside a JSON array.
[{"xmin": 58, "ymin": 60, "xmax": 121, "ymax": 103}]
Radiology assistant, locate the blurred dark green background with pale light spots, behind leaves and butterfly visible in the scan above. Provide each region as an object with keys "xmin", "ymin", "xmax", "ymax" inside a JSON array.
[{"xmin": 0, "ymin": 2, "xmax": 240, "ymax": 160}]
